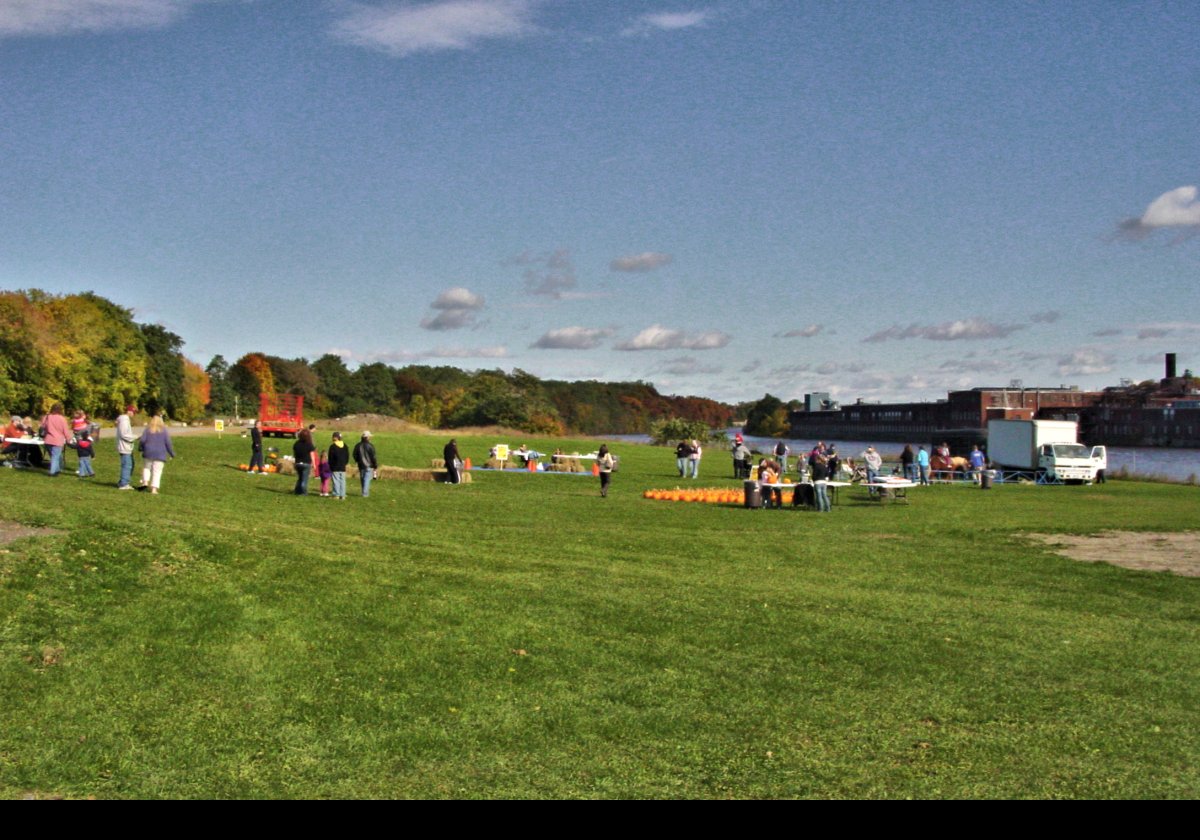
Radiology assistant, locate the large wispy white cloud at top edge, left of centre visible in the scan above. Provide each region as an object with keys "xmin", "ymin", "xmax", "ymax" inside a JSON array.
[{"xmin": 334, "ymin": 0, "xmax": 536, "ymax": 56}]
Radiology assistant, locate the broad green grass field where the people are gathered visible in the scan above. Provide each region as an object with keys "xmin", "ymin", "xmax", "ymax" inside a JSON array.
[{"xmin": 0, "ymin": 436, "xmax": 1200, "ymax": 798}]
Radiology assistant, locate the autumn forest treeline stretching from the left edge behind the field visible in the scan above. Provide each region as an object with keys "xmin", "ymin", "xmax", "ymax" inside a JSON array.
[{"xmin": 0, "ymin": 290, "xmax": 736, "ymax": 434}]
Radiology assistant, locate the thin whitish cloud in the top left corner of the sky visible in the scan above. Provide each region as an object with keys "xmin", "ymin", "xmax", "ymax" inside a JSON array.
[{"xmin": 0, "ymin": 0, "xmax": 200, "ymax": 37}]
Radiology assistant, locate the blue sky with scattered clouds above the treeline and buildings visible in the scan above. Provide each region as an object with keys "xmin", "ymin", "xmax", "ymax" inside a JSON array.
[{"xmin": 0, "ymin": 0, "xmax": 1200, "ymax": 401}]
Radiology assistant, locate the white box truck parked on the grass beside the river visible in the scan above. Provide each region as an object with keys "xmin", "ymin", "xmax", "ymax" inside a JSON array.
[{"xmin": 988, "ymin": 420, "xmax": 1109, "ymax": 484}]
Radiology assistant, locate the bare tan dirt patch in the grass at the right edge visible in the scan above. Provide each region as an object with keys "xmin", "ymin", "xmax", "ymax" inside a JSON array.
[{"xmin": 1026, "ymin": 530, "xmax": 1200, "ymax": 577}]
